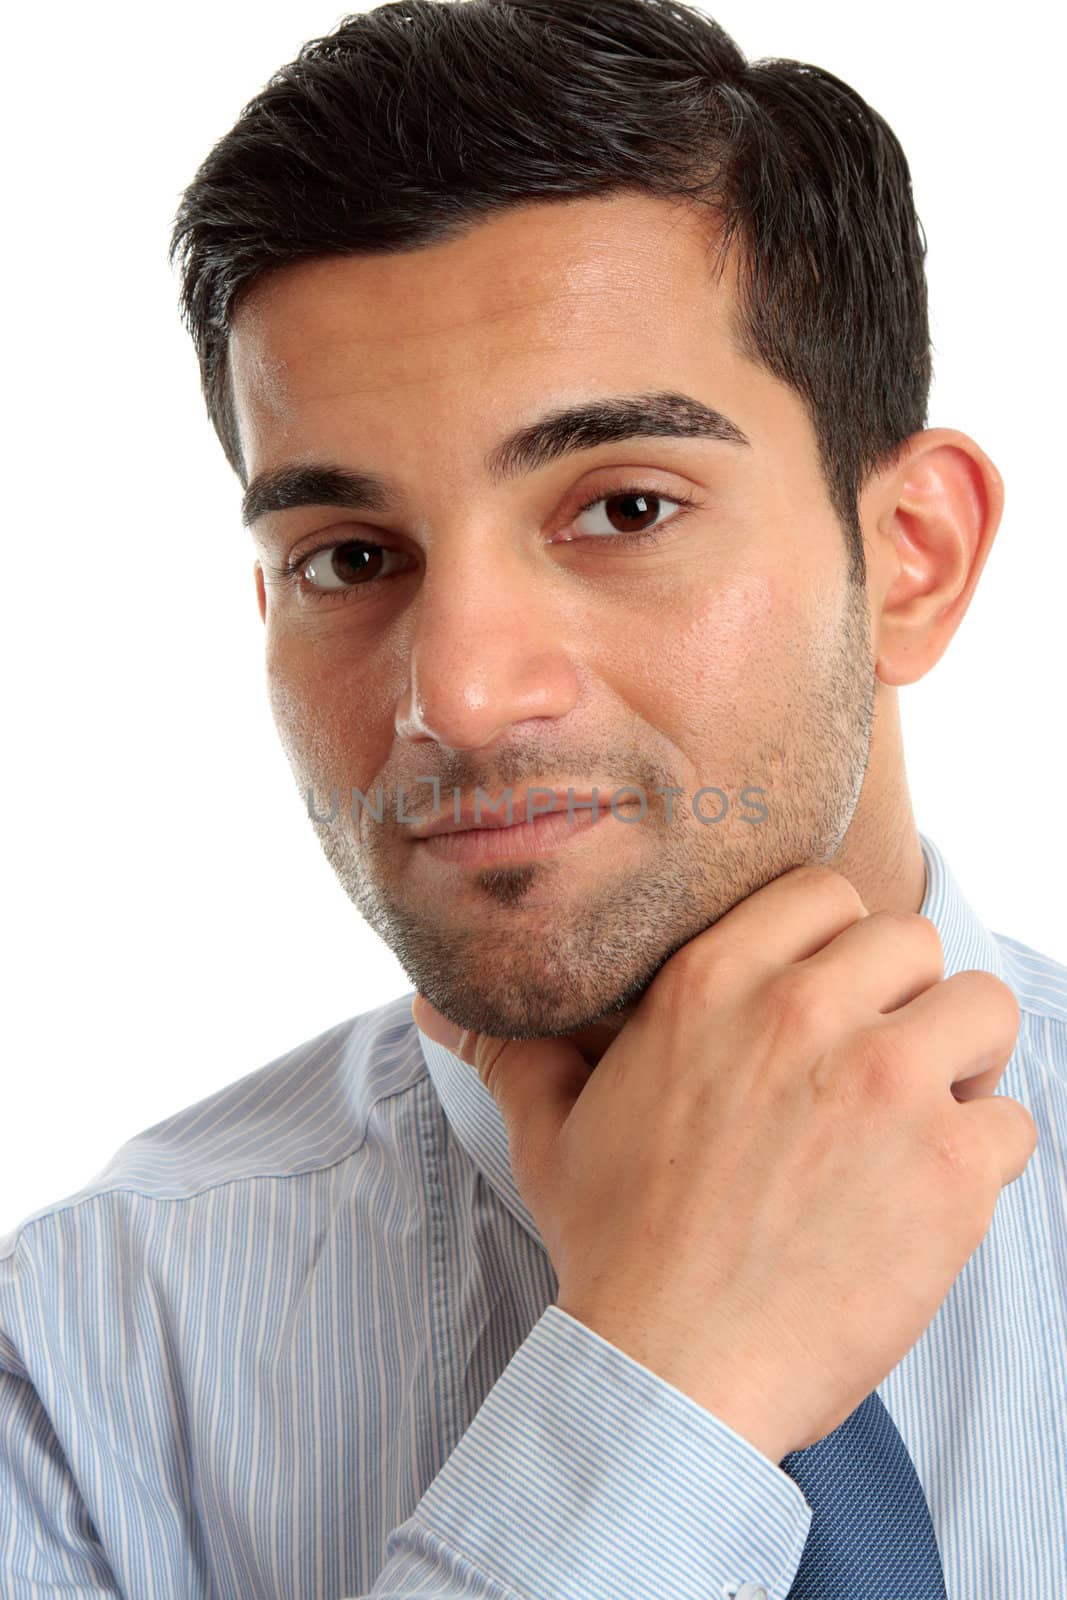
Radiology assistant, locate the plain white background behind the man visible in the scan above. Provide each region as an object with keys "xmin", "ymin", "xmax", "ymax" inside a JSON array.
[{"xmin": 0, "ymin": 0, "xmax": 1067, "ymax": 1234}]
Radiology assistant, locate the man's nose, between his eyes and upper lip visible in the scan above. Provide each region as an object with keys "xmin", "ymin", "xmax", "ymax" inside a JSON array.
[{"xmin": 395, "ymin": 547, "xmax": 581, "ymax": 750}]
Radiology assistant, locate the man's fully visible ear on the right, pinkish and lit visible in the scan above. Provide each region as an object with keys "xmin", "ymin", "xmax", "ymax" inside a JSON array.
[{"xmin": 862, "ymin": 427, "xmax": 1005, "ymax": 685}]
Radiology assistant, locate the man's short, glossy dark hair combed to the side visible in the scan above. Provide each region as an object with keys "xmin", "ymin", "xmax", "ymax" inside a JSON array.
[{"xmin": 170, "ymin": 0, "xmax": 931, "ymax": 582}]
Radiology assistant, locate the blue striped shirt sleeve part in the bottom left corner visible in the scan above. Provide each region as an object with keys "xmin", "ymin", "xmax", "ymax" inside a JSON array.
[{"xmin": 0, "ymin": 1365, "xmax": 122, "ymax": 1600}]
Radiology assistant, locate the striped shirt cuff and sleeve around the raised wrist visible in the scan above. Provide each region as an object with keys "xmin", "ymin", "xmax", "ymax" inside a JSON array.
[{"xmin": 349, "ymin": 1306, "xmax": 813, "ymax": 1600}]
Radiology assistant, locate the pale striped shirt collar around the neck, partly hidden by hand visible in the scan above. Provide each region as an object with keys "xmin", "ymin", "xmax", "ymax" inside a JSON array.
[{"xmin": 418, "ymin": 832, "xmax": 1003, "ymax": 1243}]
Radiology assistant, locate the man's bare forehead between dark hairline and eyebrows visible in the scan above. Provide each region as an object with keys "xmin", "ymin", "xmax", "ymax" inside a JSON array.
[{"xmin": 230, "ymin": 194, "xmax": 734, "ymax": 438}]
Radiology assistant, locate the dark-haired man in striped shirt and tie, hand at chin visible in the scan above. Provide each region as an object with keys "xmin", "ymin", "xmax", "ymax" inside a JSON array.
[{"xmin": 0, "ymin": 0, "xmax": 1067, "ymax": 1600}]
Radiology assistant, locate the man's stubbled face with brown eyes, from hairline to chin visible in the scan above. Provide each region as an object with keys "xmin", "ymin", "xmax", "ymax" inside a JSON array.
[{"xmin": 230, "ymin": 194, "xmax": 875, "ymax": 1037}]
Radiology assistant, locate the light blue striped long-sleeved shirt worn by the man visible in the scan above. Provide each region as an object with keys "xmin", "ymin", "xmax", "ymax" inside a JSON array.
[{"xmin": 0, "ymin": 835, "xmax": 1067, "ymax": 1600}]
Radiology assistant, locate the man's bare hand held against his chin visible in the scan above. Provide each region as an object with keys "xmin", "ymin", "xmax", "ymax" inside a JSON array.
[{"xmin": 413, "ymin": 866, "xmax": 1037, "ymax": 1462}]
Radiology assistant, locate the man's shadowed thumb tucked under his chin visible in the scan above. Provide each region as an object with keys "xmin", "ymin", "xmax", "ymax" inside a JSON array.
[{"xmin": 411, "ymin": 994, "xmax": 592, "ymax": 1176}]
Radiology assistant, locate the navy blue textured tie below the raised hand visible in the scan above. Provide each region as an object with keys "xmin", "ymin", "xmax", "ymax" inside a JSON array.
[{"xmin": 779, "ymin": 1390, "xmax": 947, "ymax": 1600}]
